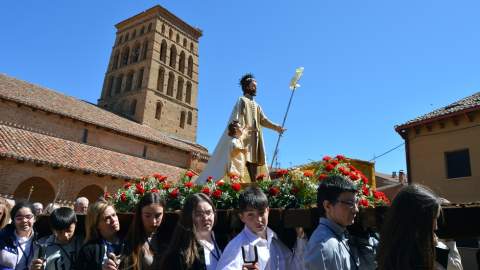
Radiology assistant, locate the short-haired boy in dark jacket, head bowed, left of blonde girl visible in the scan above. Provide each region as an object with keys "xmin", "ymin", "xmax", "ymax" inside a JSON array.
[{"xmin": 31, "ymin": 207, "xmax": 83, "ymax": 270}]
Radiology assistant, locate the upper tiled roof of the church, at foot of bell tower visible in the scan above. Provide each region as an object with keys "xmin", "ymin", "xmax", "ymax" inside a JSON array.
[{"xmin": 0, "ymin": 74, "xmax": 208, "ymax": 154}]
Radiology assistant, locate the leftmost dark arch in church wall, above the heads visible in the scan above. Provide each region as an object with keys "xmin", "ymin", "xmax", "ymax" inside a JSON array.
[{"xmin": 13, "ymin": 177, "xmax": 55, "ymax": 206}]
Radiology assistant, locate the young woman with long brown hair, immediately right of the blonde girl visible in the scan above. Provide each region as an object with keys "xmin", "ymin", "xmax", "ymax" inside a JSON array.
[{"xmin": 120, "ymin": 193, "xmax": 165, "ymax": 270}]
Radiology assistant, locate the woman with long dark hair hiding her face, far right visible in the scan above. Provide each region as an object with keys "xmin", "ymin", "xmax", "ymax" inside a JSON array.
[{"xmin": 377, "ymin": 185, "xmax": 441, "ymax": 270}]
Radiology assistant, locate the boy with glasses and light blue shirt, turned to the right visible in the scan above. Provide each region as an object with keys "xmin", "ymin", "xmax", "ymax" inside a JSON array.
[{"xmin": 304, "ymin": 176, "xmax": 358, "ymax": 270}]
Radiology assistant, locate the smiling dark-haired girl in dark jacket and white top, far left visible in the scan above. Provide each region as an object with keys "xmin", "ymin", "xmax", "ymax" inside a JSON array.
[{"xmin": 0, "ymin": 202, "xmax": 37, "ymax": 270}]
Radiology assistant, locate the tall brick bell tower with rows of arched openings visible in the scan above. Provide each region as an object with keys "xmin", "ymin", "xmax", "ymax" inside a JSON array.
[{"xmin": 98, "ymin": 5, "xmax": 202, "ymax": 142}]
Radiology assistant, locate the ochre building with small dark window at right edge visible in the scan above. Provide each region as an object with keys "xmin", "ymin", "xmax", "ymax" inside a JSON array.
[{"xmin": 395, "ymin": 92, "xmax": 480, "ymax": 202}]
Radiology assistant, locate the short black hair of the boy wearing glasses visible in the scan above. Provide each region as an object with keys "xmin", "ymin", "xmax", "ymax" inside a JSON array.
[{"xmin": 317, "ymin": 175, "xmax": 357, "ymax": 217}]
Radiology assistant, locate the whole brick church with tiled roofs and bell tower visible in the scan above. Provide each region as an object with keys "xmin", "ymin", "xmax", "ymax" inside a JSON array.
[{"xmin": 0, "ymin": 6, "xmax": 208, "ymax": 203}]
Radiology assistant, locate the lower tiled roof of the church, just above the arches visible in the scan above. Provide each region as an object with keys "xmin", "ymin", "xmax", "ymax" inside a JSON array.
[{"xmin": 0, "ymin": 125, "xmax": 184, "ymax": 180}]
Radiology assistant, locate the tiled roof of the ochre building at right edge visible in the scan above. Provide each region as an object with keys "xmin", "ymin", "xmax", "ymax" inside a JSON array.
[{"xmin": 395, "ymin": 92, "xmax": 480, "ymax": 130}]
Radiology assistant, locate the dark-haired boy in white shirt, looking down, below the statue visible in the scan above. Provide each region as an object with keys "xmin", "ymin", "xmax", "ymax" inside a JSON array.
[{"xmin": 217, "ymin": 186, "xmax": 301, "ymax": 270}]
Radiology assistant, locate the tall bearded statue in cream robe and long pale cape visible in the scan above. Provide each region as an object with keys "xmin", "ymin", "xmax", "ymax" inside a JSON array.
[{"xmin": 197, "ymin": 74, "xmax": 285, "ymax": 183}]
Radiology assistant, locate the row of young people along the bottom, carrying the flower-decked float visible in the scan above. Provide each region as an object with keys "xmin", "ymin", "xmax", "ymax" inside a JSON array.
[{"xmin": 0, "ymin": 176, "xmax": 468, "ymax": 270}]
